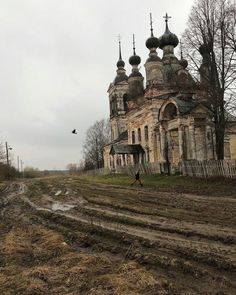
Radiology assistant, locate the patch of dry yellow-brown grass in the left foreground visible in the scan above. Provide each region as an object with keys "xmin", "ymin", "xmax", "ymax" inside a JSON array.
[{"xmin": 0, "ymin": 224, "xmax": 166, "ymax": 295}]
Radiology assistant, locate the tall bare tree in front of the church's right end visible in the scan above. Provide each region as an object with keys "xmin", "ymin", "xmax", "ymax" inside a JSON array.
[{"xmin": 183, "ymin": 0, "xmax": 236, "ymax": 159}]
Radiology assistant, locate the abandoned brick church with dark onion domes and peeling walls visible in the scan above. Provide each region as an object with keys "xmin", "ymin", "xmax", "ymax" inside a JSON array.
[{"xmin": 104, "ymin": 15, "xmax": 236, "ymax": 170}]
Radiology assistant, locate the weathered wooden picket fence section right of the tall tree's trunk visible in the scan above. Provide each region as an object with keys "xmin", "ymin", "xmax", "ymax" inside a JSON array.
[{"xmin": 180, "ymin": 160, "xmax": 236, "ymax": 178}]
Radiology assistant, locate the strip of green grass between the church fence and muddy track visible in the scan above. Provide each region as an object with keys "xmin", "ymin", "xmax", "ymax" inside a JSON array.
[{"xmin": 78, "ymin": 174, "xmax": 236, "ymax": 196}]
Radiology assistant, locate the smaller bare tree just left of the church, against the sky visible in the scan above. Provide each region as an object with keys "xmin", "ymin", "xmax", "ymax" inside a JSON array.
[{"xmin": 83, "ymin": 119, "xmax": 110, "ymax": 170}]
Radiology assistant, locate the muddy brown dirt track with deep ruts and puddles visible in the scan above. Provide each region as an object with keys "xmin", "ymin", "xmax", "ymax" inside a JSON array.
[{"xmin": 0, "ymin": 178, "xmax": 236, "ymax": 294}]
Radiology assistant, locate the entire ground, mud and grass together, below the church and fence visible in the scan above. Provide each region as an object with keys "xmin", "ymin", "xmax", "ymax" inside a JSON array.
[{"xmin": 0, "ymin": 176, "xmax": 236, "ymax": 295}]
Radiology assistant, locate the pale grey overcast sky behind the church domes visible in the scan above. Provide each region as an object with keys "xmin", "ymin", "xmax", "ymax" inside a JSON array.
[{"xmin": 0, "ymin": 0, "xmax": 194, "ymax": 169}]
